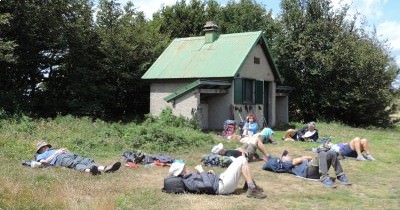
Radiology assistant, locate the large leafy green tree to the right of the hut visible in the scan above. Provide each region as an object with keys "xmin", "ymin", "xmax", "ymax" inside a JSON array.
[{"xmin": 273, "ymin": 0, "xmax": 399, "ymax": 126}]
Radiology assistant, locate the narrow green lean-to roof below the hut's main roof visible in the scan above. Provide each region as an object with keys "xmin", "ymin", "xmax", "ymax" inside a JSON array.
[{"xmin": 164, "ymin": 79, "xmax": 231, "ymax": 102}]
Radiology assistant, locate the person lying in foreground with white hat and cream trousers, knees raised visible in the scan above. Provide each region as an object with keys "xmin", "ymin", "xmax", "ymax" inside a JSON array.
[{"xmin": 169, "ymin": 156, "xmax": 267, "ymax": 199}]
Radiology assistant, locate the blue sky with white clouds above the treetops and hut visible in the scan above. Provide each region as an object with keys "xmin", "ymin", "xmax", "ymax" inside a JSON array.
[{"xmin": 112, "ymin": 0, "xmax": 400, "ymax": 83}]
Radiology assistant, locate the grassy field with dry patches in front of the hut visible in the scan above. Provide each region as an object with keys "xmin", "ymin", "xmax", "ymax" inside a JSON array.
[{"xmin": 0, "ymin": 117, "xmax": 400, "ymax": 209}]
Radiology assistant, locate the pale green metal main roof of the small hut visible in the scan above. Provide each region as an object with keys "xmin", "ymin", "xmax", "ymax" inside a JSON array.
[{"xmin": 142, "ymin": 31, "xmax": 282, "ymax": 82}]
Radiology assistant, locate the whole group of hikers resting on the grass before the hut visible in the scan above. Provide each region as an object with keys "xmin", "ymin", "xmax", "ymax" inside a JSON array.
[{"xmin": 28, "ymin": 114, "xmax": 375, "ymax": 199}]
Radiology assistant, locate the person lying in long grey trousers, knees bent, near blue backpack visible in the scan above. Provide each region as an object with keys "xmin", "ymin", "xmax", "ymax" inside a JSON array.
[{"xmin": 263, "ymin": 150, "xmax": 351, "ymax": 188}]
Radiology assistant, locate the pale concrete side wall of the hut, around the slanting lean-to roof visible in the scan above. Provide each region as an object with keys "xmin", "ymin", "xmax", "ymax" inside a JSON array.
[{"xmin": 150, "ymin": 81, "xmax": 200, "ymax": 118}]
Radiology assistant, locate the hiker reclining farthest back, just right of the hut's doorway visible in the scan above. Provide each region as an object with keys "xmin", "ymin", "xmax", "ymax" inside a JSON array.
[{"xmin": 282, "ymin": 122, "xmax": 319, "ymax": 141}]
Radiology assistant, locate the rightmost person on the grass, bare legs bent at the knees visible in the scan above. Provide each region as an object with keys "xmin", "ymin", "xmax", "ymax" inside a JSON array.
[{"xmin": 331, "ymin": 137, "xmax": 376, "ymax": 161}]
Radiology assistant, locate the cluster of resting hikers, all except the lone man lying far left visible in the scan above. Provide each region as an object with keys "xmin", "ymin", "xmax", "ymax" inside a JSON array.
[{"xmin": 169, "ymin": 115, "xmax": 375, "ymax": 198}]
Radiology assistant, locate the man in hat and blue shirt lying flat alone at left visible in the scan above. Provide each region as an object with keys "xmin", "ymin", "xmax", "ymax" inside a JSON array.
[{"xmin": 35, "ymin": 141, "xmax": 121, "ymax": 175}]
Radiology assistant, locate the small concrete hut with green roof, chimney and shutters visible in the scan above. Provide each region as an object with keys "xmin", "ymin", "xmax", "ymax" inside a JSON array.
[{"xmin": 142, "ymin": 22, "xmax": 289, "ymax": 129}]
